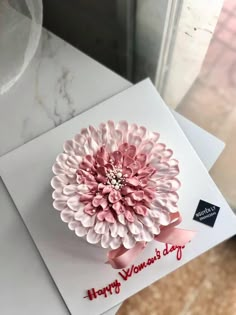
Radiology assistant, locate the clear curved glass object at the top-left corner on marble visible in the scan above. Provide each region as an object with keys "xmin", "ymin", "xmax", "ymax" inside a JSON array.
[{"xmin": 0, "ymin": 0, "xmax": 42, "ymax": 95}]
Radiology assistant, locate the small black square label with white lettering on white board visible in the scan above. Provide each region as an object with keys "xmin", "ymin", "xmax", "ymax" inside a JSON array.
[{"xmin": 193, "ymin": 200, "xmax": 220, "ymax": 227}]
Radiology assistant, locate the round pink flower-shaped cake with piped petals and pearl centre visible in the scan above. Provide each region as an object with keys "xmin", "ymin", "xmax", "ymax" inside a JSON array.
[{"xmin": 51, "ymin": 121, "xmax": 180, "ymax": 249}]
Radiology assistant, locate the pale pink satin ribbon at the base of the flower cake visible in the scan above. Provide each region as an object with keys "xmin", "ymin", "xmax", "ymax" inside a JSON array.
[{"xmin": 107, "ymin": 212, "xmax": 196, "ymax": 269}]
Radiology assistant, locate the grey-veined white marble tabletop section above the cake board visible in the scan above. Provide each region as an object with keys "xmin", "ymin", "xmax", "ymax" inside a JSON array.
[{"xmin": 0, "ymin": 31, "xmax": 131, "ymax": 156}]
